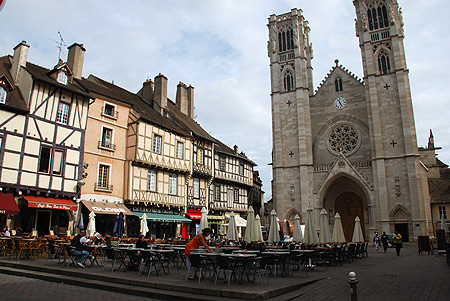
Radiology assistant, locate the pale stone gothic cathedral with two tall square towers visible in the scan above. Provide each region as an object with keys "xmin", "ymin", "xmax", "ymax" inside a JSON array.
[{"xmin": 268, "ymin": 0, "xmax": 432, "ymax": 241}]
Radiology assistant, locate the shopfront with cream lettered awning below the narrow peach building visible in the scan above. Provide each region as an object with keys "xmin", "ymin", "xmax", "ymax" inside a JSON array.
[{"xmin": 81, "ymin": 200, "xmax": 134, "ymax": 236}]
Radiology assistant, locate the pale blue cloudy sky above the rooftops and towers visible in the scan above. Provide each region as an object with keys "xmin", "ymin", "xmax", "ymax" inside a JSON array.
[{"xmin": 0, "ymin": 0, "xmax": 450, "ymax": 201}]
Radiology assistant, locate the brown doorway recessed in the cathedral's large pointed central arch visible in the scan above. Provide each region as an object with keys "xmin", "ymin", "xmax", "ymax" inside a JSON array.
[{"xmin": 334, "ymin": 192, "xmax": 365, "ymax": 241}]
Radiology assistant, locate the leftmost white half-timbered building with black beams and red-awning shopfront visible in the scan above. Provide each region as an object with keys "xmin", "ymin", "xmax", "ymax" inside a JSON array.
[{"xmin": 0, "ymin": 41, "xmax": 90, "ymax": 235}]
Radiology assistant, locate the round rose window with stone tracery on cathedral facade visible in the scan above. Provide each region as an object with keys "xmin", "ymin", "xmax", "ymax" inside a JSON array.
[{"xmin": 328, "ymin": 125, "xmax": 359, "ymax": 155}]
